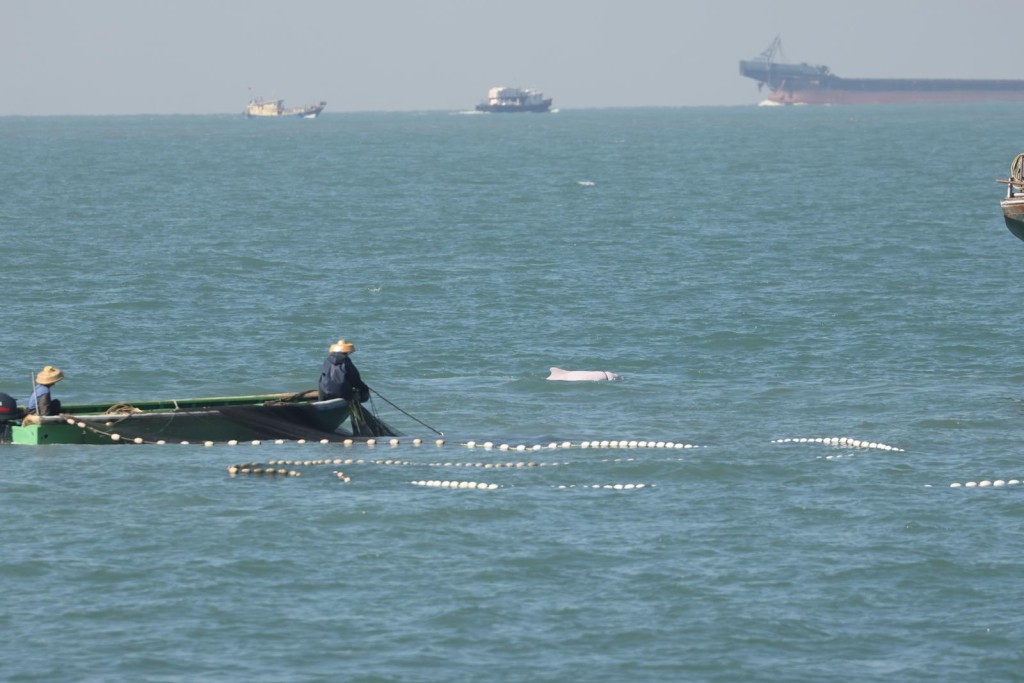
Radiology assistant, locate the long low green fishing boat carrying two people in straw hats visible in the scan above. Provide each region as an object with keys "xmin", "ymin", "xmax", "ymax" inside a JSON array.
[{"xmin": 0, "ymin": 390, "xmax": 396, "ymax": 445}]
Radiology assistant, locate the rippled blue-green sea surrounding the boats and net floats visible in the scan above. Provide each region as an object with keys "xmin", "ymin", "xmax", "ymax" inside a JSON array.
[{"xmin": 0, "ymin": 103, "xmax": 1024, "ymax": 683}]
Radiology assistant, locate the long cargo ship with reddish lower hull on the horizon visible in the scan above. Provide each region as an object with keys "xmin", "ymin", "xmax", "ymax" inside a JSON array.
[{"xmin": 739, "ymin": 37, "xmax": 1024, "ymax": 104}]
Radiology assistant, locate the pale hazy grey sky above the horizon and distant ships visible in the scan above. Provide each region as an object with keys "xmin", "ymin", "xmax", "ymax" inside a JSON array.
[{"xmin": 0, "ymin": 0, "xmax": 1024, "ymax": 116}]
